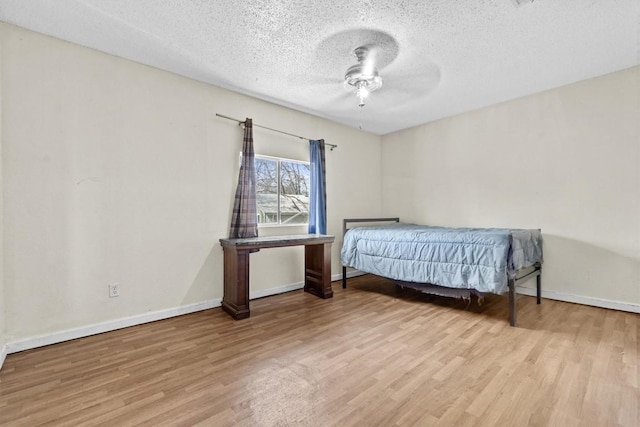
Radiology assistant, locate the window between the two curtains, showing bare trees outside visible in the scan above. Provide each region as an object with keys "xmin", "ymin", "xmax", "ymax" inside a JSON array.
[{"xmin": 255, "ymin": 156, "xmax": 310, "ymax": 225}]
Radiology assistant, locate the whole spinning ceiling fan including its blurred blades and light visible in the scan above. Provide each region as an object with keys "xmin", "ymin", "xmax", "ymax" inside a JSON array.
[{"xmin": 287, "ymin": 28, "xmax": 440, "ymax": 116}]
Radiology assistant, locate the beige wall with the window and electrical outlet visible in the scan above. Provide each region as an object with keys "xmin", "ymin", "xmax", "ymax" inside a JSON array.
[{"xmin": 0, "ymin": 24, "xmax": 381, "ymax": 341}]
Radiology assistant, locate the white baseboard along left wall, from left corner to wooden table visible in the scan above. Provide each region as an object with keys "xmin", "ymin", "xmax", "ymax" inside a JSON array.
[{"xmin": 6, "ymin": 298, "xmax": 221, "ymax": 354}]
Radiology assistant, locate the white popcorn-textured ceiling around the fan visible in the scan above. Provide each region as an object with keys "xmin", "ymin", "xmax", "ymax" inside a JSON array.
[{"xmin": 0, "ymin": 0, "xmax": 640, "ymax": 134}]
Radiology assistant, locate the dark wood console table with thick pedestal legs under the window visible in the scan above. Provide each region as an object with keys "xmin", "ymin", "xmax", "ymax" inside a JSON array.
[{"xmin": 220, "ymin": 234, "xmax": 335, "ymax": 320}]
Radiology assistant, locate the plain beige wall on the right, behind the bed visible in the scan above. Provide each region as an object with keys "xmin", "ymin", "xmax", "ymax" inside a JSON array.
[{"xmin": 382, "ymin": 67, "xmax": 640, "ymax": 308}]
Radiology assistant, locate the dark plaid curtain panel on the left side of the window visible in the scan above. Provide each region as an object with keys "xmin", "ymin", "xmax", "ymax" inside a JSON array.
[{"xmin": 229, "ymin": 118, "xmax": 258, "ymax": 239}]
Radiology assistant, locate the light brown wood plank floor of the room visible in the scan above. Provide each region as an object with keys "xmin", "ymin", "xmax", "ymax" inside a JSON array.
[{"xmin": 0, "ymin": 276, "xmax": 640, "ymax": 427}]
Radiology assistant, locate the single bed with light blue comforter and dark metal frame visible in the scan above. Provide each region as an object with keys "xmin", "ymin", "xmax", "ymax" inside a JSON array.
[{"xmin": 340, "ymin": 218, "xmax": 543, "ymax": 326}]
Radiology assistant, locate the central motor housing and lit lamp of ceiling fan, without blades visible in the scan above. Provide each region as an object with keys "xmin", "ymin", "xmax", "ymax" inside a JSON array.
[{"xmin": 344, "ymin": 46, "xmax": 382, "ymax": 107}]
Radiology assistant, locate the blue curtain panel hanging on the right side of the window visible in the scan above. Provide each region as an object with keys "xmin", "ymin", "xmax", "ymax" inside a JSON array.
[{"xmin": 309, "ymin": 139, "xmax": 327, "ymax": 234}]
